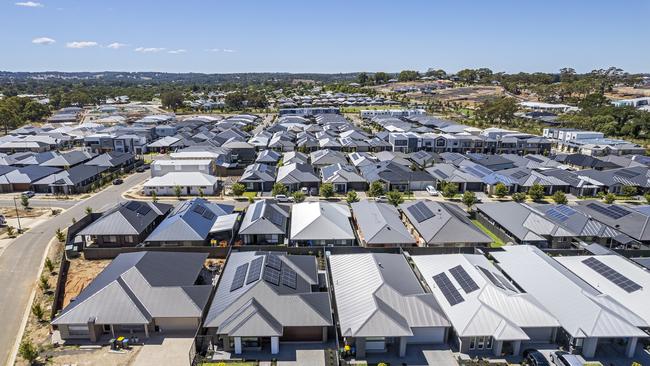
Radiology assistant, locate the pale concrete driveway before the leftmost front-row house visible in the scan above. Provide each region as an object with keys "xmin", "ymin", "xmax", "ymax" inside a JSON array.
[{"xmin": 132, "ymin": 336, "xmax": 194, "ymax": 366}]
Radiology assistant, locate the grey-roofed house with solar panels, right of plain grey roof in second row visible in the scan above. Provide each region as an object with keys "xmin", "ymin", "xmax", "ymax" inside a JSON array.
[{"xmin": 399, "ymin": 200, "xmax": 492, "ymax": 247}]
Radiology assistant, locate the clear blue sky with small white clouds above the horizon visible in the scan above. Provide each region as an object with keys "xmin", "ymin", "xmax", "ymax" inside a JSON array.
[{"xmin": 0, "ymin": 0, "xmax": 650, "ymax": 73}]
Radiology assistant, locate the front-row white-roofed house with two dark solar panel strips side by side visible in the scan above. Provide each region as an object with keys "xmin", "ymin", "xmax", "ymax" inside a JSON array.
[{"xmin": 411, "ymin": 254, "xmax": 560, "ymax": 357}]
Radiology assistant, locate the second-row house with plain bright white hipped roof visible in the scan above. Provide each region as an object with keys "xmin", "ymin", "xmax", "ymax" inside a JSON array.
[{"xmin": 289, "ymin": 201, "xmax": 356, "ymax": 246}]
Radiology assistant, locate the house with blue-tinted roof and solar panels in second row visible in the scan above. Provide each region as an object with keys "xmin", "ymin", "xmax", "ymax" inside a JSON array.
[{"xmin": 145, "ymin": 198, "xmax": 239, "ymax": 246}]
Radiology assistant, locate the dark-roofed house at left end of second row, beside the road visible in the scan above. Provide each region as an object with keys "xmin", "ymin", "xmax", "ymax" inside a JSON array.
[{"xmin": 77, "ymin": 201, "xmax": 174, "ymax": 248}]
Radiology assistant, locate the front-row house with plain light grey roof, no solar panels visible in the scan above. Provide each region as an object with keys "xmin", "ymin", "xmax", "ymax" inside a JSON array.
[{"xmin": 328, "ymin": 253, "xmax": 450, "ymax": 359}]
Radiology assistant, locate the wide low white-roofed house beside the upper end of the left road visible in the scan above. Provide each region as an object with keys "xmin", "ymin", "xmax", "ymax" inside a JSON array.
[{"xmin": 143, "ymin": 172, "xmax": 219, "ymax": 196}]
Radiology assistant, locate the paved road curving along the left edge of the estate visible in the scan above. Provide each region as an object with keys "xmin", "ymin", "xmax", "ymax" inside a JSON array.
[{"xmin": 0, "ymin": 172, "xmax": 148, "ymax": 365}]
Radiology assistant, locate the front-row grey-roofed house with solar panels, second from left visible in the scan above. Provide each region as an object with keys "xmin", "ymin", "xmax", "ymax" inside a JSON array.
[{"xmin": 203, "ymin": 252, "xmax": 334, "ymax": 355}]
